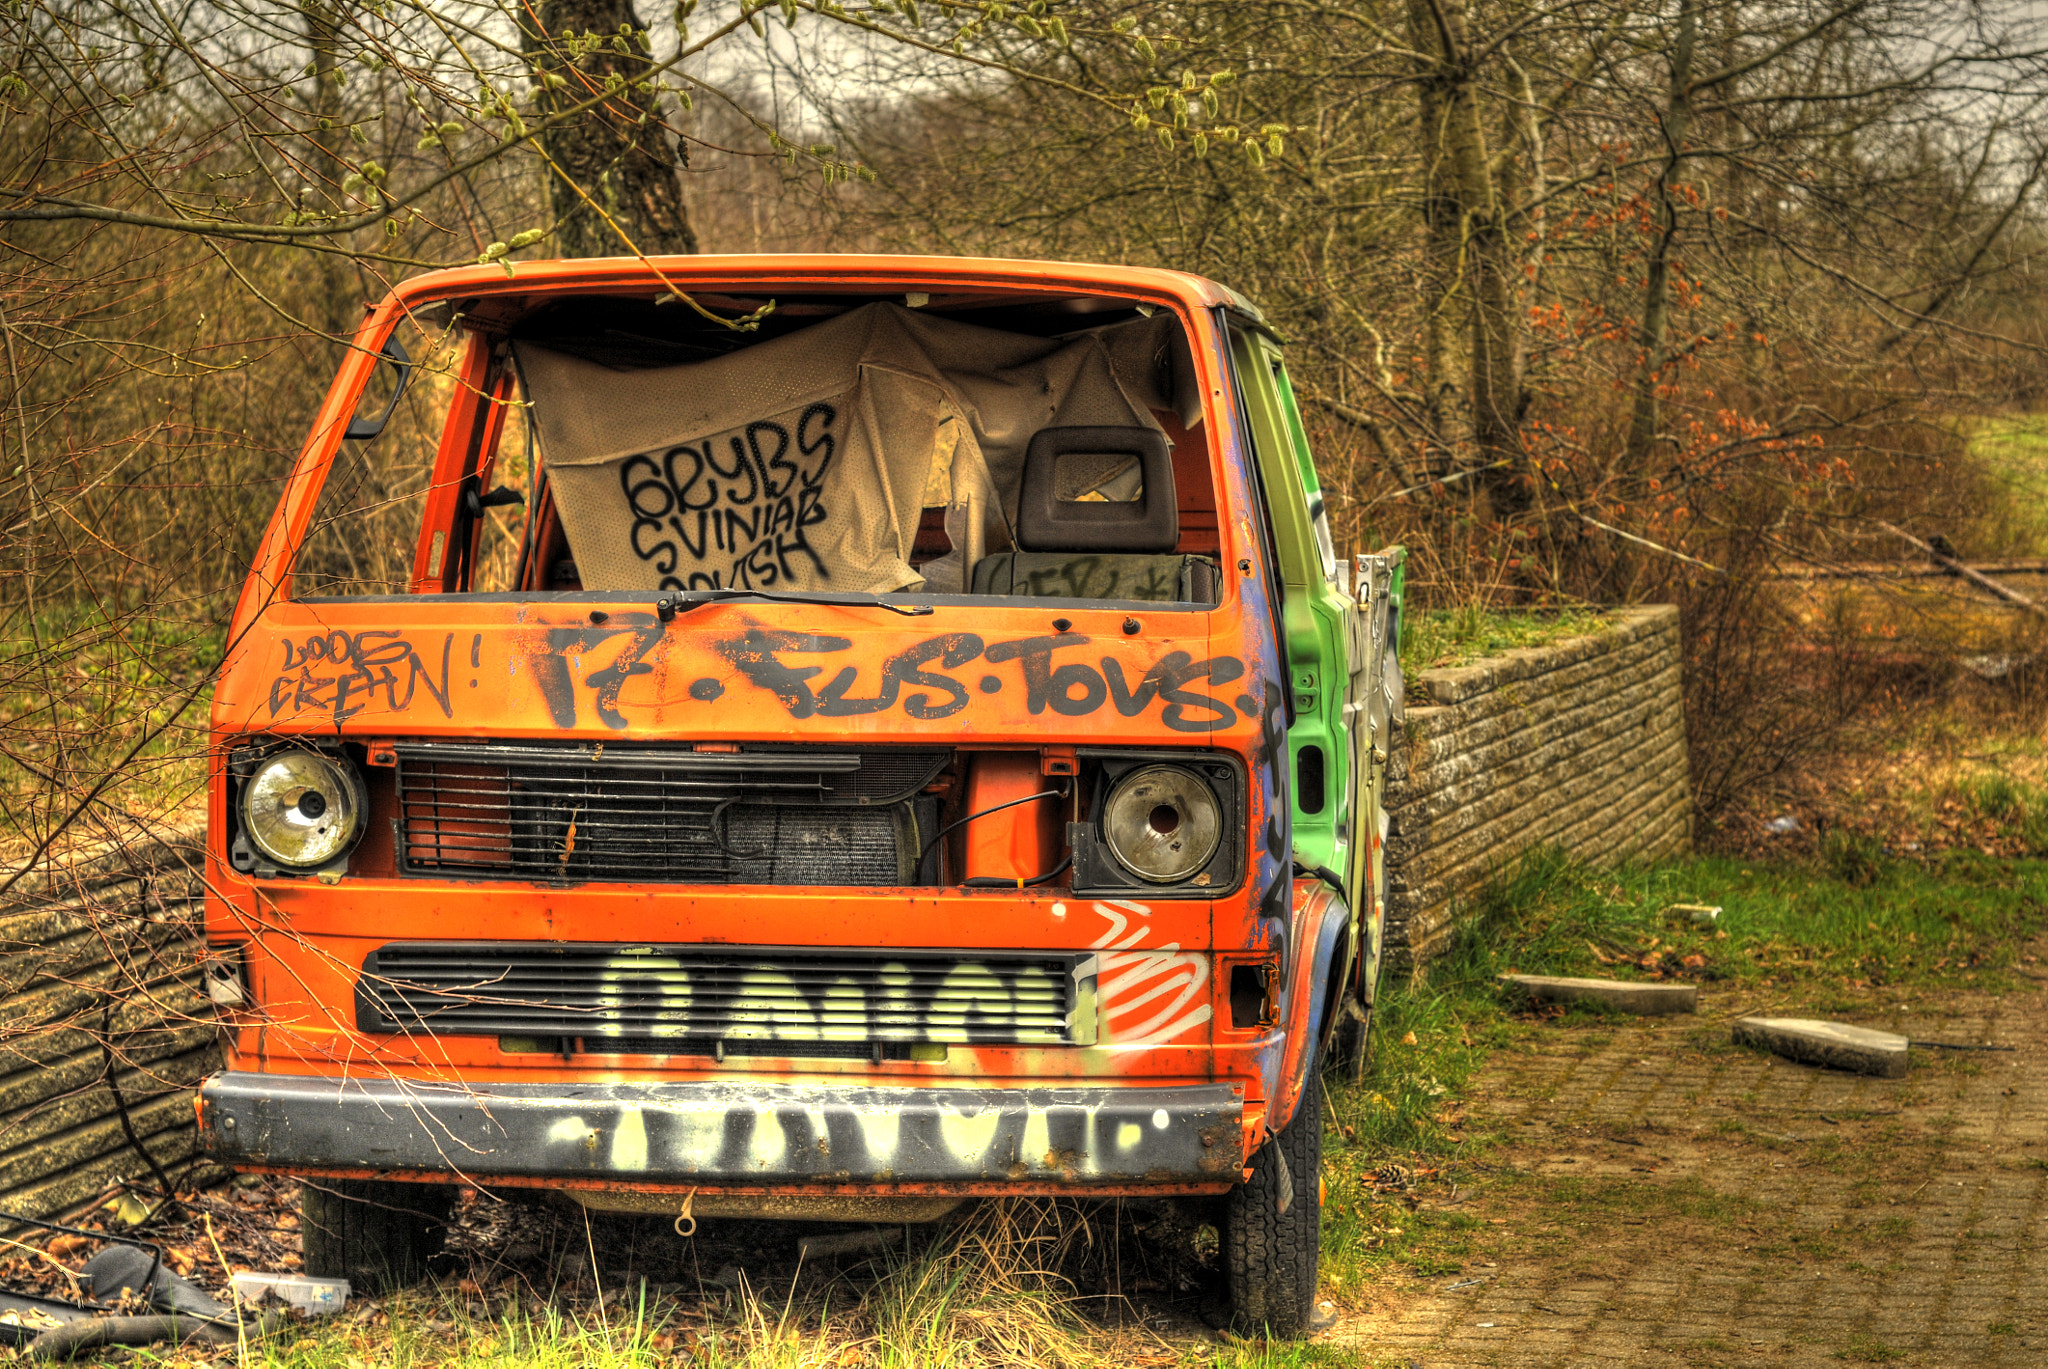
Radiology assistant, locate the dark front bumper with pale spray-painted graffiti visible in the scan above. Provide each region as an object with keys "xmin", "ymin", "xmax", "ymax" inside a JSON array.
[{"xmin": 199, "ymin": 1072, "xmax": 1245, "ymax": 1189}]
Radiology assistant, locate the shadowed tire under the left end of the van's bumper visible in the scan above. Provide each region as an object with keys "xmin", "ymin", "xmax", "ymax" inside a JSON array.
[{"xmin": 299, "ymin": 1178, "xmax": 455, "ymax": 1293}]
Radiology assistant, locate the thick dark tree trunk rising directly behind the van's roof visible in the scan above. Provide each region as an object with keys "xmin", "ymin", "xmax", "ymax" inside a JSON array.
[{"xmin": 524, "ymin": 0, "xmax": 696, "ymax": 256}]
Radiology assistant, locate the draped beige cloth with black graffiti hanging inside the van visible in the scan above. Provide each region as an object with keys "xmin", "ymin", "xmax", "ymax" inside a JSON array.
[{"xmin": 518, "ymin": 303, "xmax": 1186, "ymax": 592}]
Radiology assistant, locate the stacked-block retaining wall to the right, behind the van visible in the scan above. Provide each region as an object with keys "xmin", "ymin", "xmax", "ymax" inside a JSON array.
[{"xmin": 1386, "ymin": 605, "xmax": 1692, "ymax": 967}]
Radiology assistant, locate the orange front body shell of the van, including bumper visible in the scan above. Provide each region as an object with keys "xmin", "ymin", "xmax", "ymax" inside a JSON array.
[{"xmin": 199, "ymin": 256, "xmax": 1376, "ymax": 1211}]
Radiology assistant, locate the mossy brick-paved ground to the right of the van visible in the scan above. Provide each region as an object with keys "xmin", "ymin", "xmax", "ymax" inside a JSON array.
[{"xmin": 1329, "ymin": 943, "xmax": 2048, "ymax": 1369}]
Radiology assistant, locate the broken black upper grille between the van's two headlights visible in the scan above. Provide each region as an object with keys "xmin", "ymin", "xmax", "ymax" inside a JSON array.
[{"xmin": 395, "ymin": 742, "xmax": 948, "ymax": 885}]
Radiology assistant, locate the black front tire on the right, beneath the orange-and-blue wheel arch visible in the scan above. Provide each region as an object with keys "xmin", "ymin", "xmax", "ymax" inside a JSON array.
[{"xmin": 1223, "ymin": 1068, "xmax": 1323, "ymax": 1340}]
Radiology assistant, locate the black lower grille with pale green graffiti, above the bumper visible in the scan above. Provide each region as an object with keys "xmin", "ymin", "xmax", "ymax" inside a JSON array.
[{"xmin": 356, "ymin": 941, "xmax": 1096, "ymax": 1053}]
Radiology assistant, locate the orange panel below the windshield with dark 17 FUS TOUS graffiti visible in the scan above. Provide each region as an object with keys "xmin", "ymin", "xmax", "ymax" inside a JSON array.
[{"xmin": 213, "ymin": 594, "xmax": 1278, "ymax": 746}]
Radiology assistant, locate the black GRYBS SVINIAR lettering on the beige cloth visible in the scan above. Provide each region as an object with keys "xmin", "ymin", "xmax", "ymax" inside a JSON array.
[{"xmin": 618, "ymin": 404, "xmax": 838, "ymax": 590}]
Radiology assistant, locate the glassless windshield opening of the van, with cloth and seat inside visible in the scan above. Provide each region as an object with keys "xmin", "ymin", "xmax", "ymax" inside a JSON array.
[{"xmin": 295, "ymin": 293, "xmax": 1221, "ymax": 605}]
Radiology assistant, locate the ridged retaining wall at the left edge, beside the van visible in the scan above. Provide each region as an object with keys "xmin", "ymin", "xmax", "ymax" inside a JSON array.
[{"xmin": 0, "ymin": 834, "xmax": 219, "ymax": 1217}]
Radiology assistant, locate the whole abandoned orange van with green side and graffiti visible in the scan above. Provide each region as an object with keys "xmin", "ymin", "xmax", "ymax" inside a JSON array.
[{"xmin": 199, "ymin": 256, "xmax": 1399, "ymax": 1334}]
